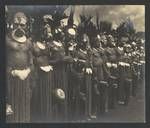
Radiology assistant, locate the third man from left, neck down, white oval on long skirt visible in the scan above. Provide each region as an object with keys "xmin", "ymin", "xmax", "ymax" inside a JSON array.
[{"xmin": 49, "ymin": 36, "xmax": 72, "ymax": 120}]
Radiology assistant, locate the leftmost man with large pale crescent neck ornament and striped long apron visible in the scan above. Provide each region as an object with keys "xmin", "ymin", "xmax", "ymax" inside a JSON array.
[{"xmin": 6, "ymin": 12, "xmax": 33, "ymax": 123}]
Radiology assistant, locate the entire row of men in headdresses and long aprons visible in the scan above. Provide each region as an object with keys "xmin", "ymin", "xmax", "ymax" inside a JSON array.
[{"xmin": 6, "ymin": 12, "xmax": 144, "ymax": 122}]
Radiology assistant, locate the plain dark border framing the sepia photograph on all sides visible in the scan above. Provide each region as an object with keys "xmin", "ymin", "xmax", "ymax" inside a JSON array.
[{"xmin": 0, "ymin": 0, "xmax": 150, "ymax": 128}]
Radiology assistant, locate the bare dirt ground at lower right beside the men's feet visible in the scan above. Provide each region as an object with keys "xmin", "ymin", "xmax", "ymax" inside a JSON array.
[{"xmin": 90, "ymin": 82, "xmax": 145, "ymax": 123}]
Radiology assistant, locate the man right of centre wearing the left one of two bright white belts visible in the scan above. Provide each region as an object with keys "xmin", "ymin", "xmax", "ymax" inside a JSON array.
[{"xmin": 105, "ymin": 35, "xmax": 118, "ymax": 109}]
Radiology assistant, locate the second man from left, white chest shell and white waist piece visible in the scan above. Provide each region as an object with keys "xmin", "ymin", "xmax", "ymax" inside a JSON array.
[{"xmin": 32, "ymin": 14, "xmax": 54, "ymax": 122}]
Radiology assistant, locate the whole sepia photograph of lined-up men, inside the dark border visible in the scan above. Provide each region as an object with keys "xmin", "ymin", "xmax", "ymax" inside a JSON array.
[{"xmin": 5, "ymin": 5, "xmax": 145, "ymax": 123}]
